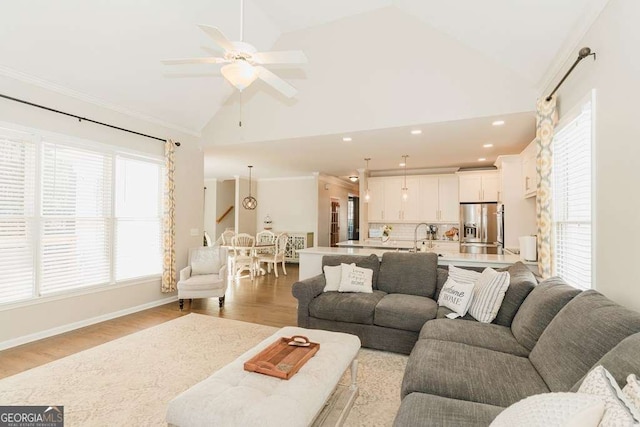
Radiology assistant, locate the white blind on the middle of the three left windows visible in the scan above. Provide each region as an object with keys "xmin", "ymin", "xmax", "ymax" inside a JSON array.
[{"xmin": 40, "ymin": 142, "xmax": 113, "ymax": 295}]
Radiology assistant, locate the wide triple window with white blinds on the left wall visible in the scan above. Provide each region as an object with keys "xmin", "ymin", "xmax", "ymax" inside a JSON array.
[{"xmin": 0, "ymin": 122, "xmax": 163, "ymax": 303}]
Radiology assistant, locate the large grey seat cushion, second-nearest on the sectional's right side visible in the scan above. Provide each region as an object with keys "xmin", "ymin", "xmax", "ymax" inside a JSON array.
[{"xmin": 401, "ymin": 340, "xmax": 549, "ymax": 407}]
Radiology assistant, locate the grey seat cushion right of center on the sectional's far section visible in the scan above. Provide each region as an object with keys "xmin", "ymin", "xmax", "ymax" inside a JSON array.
[{"xmin": 373, "ymin": 294, "xmax": 438, "ymax": 332}]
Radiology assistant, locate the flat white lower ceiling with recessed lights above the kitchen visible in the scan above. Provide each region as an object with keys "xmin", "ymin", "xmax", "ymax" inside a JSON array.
[{"xmin": 204, "ymin": 113, "xmax": 535, "ymax": 179}]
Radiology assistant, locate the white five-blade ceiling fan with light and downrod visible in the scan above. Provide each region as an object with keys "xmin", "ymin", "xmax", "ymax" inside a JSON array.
[{"xmin": 162, "ymin": 0, "xmax": 307, "ymax": 98}]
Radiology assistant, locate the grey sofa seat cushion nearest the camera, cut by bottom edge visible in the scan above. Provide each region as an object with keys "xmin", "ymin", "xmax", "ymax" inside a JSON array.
[{"xmin": 393, "ymin": 393, "xmax": 504, "ymax": 427}]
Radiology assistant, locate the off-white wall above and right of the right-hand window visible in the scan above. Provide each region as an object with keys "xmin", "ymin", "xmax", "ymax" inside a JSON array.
[{"xmin": 540, "ymin": 0, "xmax": 640, "ymax": 310}]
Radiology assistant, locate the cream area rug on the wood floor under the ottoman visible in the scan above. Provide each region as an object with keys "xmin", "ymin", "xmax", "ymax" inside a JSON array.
[{"xmin": 0, "ymin": 314, "xmax": 407, "ymax": 426}]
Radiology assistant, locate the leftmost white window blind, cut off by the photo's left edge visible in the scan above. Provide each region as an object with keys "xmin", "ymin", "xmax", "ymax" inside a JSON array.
[{"xmin": 0, "ymin": 129, "xmax": 36, "ymax": 303}]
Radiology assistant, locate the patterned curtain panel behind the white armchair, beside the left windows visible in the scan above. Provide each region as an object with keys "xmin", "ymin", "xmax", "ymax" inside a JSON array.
[{"xmin": 162, "ymin": 139, "xmax": 176, "ymax": 292}]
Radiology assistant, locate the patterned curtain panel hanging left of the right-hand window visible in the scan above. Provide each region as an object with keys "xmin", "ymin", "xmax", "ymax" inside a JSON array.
[{"xmin": 536, "ymin": 97, "xmax": 557, "ymax": 279}]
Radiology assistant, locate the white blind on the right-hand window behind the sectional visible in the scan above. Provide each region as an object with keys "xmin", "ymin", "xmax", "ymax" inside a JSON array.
[{"xmin": 553, "ymin": 101, "xmax": 592, "ymax": 288}]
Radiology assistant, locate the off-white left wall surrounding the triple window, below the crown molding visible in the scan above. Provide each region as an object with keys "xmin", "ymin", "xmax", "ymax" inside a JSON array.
[{"xmin": 0, "ymin": 76, "xmax": 204, "ymax": 346}]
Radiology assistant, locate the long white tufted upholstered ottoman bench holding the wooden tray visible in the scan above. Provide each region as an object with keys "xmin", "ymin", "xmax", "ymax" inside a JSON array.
[{"xmin": 167, "ymin": 326, "xmax": 360, "ymax": 427}]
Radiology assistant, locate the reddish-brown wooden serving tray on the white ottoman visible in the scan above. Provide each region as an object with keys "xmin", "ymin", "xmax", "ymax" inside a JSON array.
[{"xmin": 244, "ymin": 335, "xmax": 320, "ymax": 380}]
